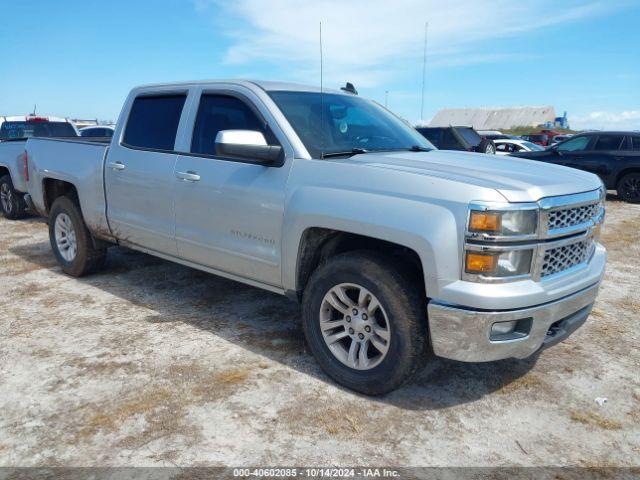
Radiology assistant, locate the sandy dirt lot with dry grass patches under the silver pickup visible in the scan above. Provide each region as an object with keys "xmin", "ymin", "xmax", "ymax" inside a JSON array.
[{"xmin": 0, "ymin": 194, "xmax": 640, "ymax": 466}]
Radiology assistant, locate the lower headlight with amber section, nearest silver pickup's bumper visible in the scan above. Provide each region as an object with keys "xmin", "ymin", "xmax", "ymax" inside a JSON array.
[{"xmin": 465, "ymin": 249, "xmax": 533, "ymax": 278}]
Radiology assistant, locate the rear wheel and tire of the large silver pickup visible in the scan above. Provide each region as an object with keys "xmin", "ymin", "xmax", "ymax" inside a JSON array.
[{"xmin": 49, "ymin": 197, "xmax": 107, "ymax": 277}]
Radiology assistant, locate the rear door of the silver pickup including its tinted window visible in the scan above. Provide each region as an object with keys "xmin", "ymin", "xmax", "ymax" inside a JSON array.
[{"xmin": 105, "ymin": 91, "xmax": 187, "ymax": 256}]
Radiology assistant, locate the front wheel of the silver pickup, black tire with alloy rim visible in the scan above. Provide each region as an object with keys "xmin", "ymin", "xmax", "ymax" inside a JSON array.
[{"xmin": 302, "ymin": 251, "xmax": 428, "ymax": 395}]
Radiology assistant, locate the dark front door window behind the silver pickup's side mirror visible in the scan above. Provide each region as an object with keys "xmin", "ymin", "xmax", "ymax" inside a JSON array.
[{"xmin": 191, "ymin": 95, "xmax": 270, "ymax": 155}]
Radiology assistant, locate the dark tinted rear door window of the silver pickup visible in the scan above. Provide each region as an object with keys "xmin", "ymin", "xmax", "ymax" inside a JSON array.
[{"xmin": 124, "ymin": 95, "xmax": 187, "ymax": 151}]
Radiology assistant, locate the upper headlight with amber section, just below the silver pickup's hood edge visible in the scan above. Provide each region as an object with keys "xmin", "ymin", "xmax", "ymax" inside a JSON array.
[{"xmin": 468, "ymin": 209, "xmax": 538, "ymax": 237}]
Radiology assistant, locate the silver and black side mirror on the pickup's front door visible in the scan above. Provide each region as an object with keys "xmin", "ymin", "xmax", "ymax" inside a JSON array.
[{"xmin": 216, "ymin": 130, "xmax": 282, "ymax": 165}]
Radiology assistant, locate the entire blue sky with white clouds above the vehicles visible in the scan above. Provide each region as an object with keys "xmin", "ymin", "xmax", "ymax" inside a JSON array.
[{"xmin": 0, "ymin": 0, "xmax": 640, "ymax": 129}]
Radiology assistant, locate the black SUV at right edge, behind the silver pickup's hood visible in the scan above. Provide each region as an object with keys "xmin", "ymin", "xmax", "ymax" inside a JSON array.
[{"xmin": 512, "ymin": 132, "xmax": 640, "ymax": 203}]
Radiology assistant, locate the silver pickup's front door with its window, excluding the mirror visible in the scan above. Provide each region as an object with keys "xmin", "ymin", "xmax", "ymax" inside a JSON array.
[{"xmin": 173, "ymin": 86, "xmax": 292, "ymax": 287}]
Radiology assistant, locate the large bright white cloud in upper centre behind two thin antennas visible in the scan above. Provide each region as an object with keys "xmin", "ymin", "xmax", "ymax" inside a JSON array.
[{"xmin": 194, "ymin": 0, "xmax": 624, "ymax": 87}]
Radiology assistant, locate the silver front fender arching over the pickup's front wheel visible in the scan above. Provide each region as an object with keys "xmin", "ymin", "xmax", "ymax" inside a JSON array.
[{"xmin": 282, "ymin": 186, "xmax": 466, "ymax": 294}]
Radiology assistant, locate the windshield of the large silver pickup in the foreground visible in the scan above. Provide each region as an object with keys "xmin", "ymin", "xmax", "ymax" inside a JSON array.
[{"xmin": 269, "ymin": 91, "xmax": 435, "ymax": 158}]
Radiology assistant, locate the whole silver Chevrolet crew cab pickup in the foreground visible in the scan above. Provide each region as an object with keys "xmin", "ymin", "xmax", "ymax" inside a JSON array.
[{"xmin": 27, "ymin": 81, "xmax": 606, "ymax": 395}]
